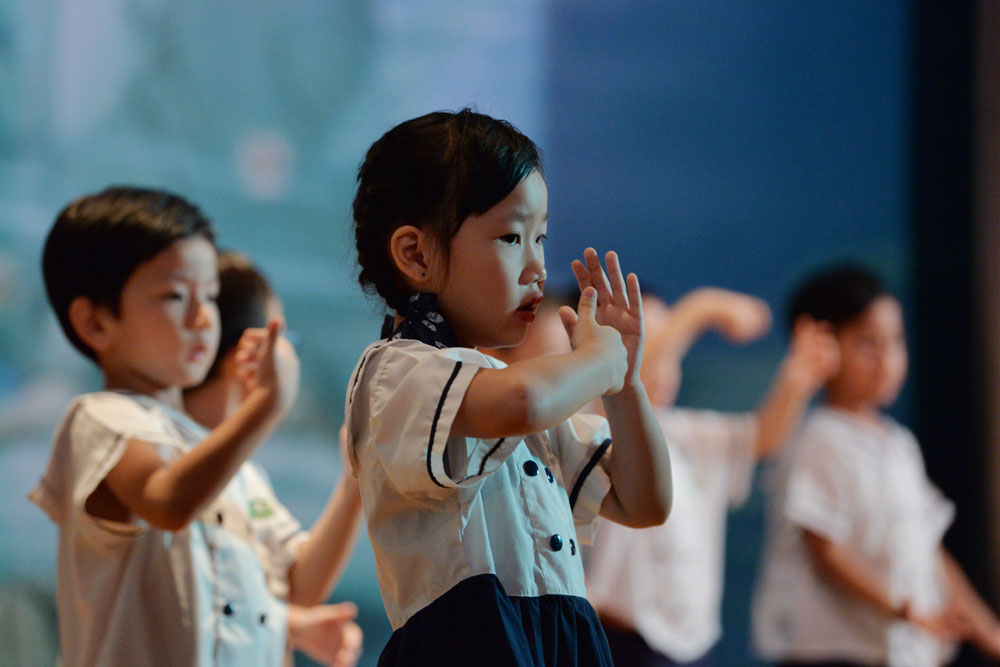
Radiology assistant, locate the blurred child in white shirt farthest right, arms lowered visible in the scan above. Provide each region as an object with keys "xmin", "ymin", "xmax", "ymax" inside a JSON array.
[{"xmin": 754, "ymin": 267, "xmax": 1000, "ymax": 667}]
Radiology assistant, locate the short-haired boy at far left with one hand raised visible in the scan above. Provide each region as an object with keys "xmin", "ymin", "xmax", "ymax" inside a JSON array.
[{"xmin": 30, "ymin": 187, "xmax": 362, "ymax": 666}]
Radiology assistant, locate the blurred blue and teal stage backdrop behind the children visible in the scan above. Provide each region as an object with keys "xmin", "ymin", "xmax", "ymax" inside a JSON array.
[{"xmin": 0, "ymin": 0, "xmax": 1000, "ymax": 665}]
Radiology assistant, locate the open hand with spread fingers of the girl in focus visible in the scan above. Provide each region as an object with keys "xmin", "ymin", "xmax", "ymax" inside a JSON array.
[{"xmin": 572, "ymin": 248, "xmax": 645, "ymax": 385}]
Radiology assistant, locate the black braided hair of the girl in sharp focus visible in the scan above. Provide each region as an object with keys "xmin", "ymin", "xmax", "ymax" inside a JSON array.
[{"xmin": 353, "ymin": 109, "xmax": 542, "ymax": 311}]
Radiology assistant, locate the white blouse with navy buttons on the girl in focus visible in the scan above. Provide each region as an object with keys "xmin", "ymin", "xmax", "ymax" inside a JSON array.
[{"xmin": 346, "ymin": 339, "xmax": 610, "ymax": 629}]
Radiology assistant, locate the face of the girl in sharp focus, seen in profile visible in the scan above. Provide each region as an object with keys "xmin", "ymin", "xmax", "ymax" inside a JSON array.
[{"xmin": 434, "ymin": 170, "xmax": 549, "ymax": 347}]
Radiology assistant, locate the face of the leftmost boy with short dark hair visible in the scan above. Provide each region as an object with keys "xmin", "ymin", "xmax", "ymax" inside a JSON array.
[{"xmin": 98, "ymin": 237, "xmax": 219, "ymax": 394}]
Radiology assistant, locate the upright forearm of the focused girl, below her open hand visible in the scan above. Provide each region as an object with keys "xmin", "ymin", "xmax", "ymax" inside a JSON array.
[{"xmin": 601, "ymin": 382, "xmax": 673, "ymax": 528}]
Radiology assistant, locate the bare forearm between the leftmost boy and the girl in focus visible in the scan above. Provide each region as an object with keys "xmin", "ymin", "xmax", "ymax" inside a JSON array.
[{"xmin": 288, "ymin": 472, "xmax": 361, "ymax": 607}]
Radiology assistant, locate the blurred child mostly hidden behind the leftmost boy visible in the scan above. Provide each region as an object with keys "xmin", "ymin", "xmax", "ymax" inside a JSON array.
[{"xmin": 184, "ymin": 251, "xmax": 361, "ymax": 667}]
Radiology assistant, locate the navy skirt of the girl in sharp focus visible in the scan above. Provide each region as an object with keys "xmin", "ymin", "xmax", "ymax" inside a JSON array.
[{"xmin": 378, "ymin": 574, "xmax": 612, "ymax": 667}]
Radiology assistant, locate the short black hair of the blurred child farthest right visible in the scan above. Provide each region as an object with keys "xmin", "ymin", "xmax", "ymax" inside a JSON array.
[{"xmin": 788, "ymin": 264, "xmax": 890, "ymax": 329}]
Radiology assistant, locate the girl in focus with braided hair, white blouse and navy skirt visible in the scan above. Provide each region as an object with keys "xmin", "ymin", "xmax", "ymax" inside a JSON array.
[{"xmin": 346, "ymin": 110, "xmax": 671, "ymax": 665}]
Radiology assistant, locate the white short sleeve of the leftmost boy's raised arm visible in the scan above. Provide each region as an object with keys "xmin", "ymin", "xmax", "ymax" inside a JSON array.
[{"xmin": 28, "ymin": 392, "xmax": 181, "ymax": 524}]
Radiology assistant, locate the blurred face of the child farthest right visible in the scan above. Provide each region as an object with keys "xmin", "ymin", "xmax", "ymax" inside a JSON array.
[{"xmin": 827, "ymin": 295, "xmax": 907, "ymax": 409}]
